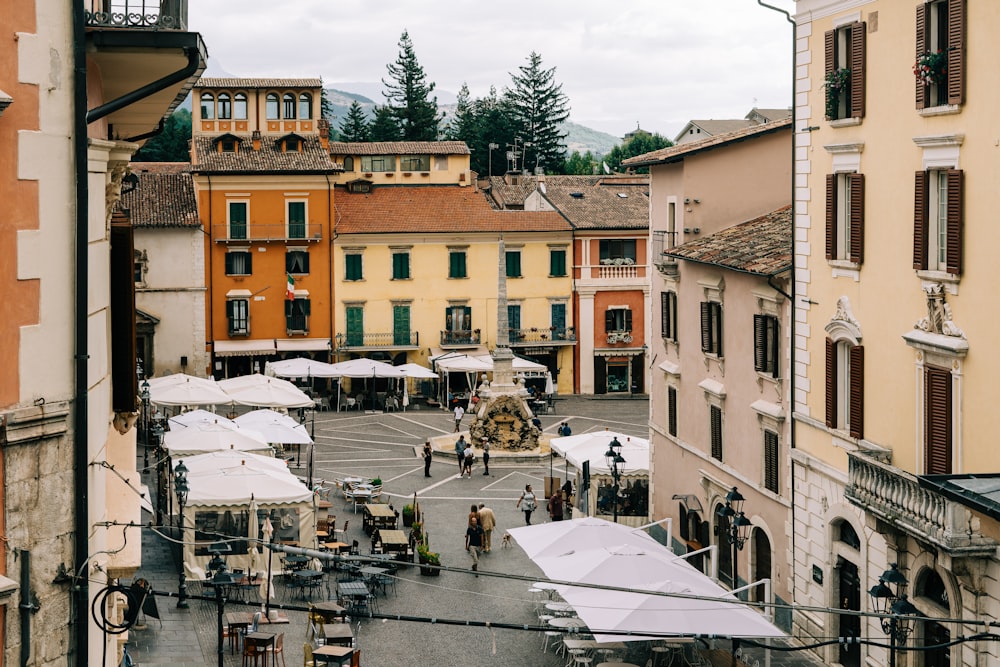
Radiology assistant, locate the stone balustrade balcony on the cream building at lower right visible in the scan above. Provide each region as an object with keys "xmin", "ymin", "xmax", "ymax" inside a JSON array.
[{"xmin": 845, "ymin": 452, "xmax": 997, "ymax": 557}]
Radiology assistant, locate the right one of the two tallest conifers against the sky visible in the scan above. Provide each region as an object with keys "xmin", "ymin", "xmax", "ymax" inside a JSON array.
[{"xmin": 504, "ymin": 51, "xmax": 569, "ymax": 172}]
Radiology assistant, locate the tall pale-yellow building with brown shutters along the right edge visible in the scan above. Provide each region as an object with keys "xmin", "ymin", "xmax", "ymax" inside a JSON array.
[{"xmin": 792, "ymin": 0, "xmax": 1000, "ymax": 665}]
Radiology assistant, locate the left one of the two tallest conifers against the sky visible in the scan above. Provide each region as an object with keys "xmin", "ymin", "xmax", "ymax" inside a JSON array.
[{"xmin": 382, "ymin": 30, "xmax": 441, "ymax": 141}]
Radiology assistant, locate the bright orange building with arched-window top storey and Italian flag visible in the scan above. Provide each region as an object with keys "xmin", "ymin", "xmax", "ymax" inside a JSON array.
[{"xmin": 191, "ymin": 79, "xmax": 342, "ymax": 377}]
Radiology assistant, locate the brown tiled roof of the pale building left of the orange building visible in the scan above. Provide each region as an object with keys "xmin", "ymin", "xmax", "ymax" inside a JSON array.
[{"xmin": 122, "ymin": 162, "xmax": 201, "ymax": 227}]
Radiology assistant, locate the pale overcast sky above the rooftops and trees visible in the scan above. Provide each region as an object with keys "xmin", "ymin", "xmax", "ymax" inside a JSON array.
[{"xmin": 189, "ymin": 0, "xmax": 794, "ymax": 138}]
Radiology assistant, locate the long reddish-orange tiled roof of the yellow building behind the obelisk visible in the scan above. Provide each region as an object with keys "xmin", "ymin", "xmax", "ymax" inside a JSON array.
[{"xmin": 336, "ymin": 185, "xmax": 571, "ymax": 234}]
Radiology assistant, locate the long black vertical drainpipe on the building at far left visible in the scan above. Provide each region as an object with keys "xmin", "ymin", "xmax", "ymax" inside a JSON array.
[{"xmin": 71, "ymin": 2, "xmax": 90, "ymax": 665}]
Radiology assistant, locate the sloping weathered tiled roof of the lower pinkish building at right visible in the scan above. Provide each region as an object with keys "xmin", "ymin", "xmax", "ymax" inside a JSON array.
[{"xmin": 663, "ymin": 206, "xmax": 792, "ymax": 276}]
